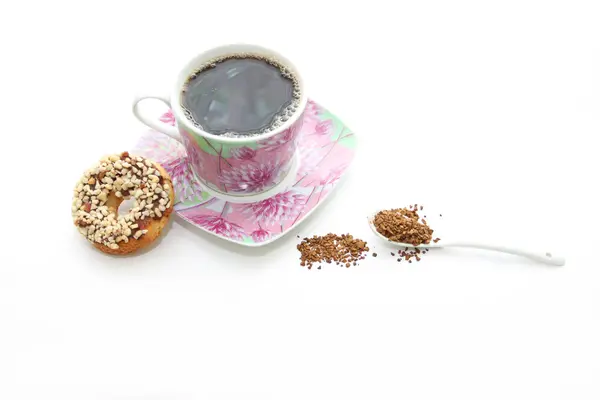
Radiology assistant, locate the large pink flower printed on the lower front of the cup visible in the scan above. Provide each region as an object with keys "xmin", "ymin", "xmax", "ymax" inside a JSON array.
[{"xmin": 221, "ymin": 162, "xmax": 281, "ymax": 192}]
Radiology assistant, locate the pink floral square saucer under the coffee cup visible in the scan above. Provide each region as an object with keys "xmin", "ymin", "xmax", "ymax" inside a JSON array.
[{"xmin": 131, "ymin": 100, "xmax": 357, "ymax": 247}]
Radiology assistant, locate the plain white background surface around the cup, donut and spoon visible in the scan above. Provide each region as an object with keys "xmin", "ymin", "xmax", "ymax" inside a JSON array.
[{"xmin": 0, "ymin": 0, "xmax": 600, "ymax": 400}]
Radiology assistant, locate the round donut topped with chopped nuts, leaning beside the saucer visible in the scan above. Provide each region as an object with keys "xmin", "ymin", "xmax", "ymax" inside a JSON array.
[{"xmin": 71, "ymin": 152, "xmax": 175, "ymax": 255}]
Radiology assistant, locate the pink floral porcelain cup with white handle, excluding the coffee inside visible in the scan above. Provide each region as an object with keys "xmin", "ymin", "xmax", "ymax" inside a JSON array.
[{"xmin": 133, "ymin": 44, "xmax": 307, "ymax": 196}]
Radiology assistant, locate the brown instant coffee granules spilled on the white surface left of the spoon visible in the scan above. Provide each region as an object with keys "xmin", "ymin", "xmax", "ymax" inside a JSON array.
[{"xmin": 296, "ymin": 233, "xmax": 368, "ymax": 269}]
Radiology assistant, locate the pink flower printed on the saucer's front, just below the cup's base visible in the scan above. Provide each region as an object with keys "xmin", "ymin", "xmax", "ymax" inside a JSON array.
[{"xmin": 241, "ymin": 190, "xmax": 306, "ymax": 225}]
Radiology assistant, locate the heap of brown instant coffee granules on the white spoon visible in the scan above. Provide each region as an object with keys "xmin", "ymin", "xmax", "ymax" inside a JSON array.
[{"xmin": 373, "ymin": 204, "xmax": 433, "ymax": 246}]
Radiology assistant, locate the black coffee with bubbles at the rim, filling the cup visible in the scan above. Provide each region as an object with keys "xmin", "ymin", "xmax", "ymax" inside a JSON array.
[{"xmin": 181, "ymin": 54, "xmax": 300, "ymax": 137}]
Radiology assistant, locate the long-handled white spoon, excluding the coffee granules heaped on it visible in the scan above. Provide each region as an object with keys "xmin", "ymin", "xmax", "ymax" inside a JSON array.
[{"xmin": 368, "ymin": 214, "xmax": 565, "ymax": 266}]
